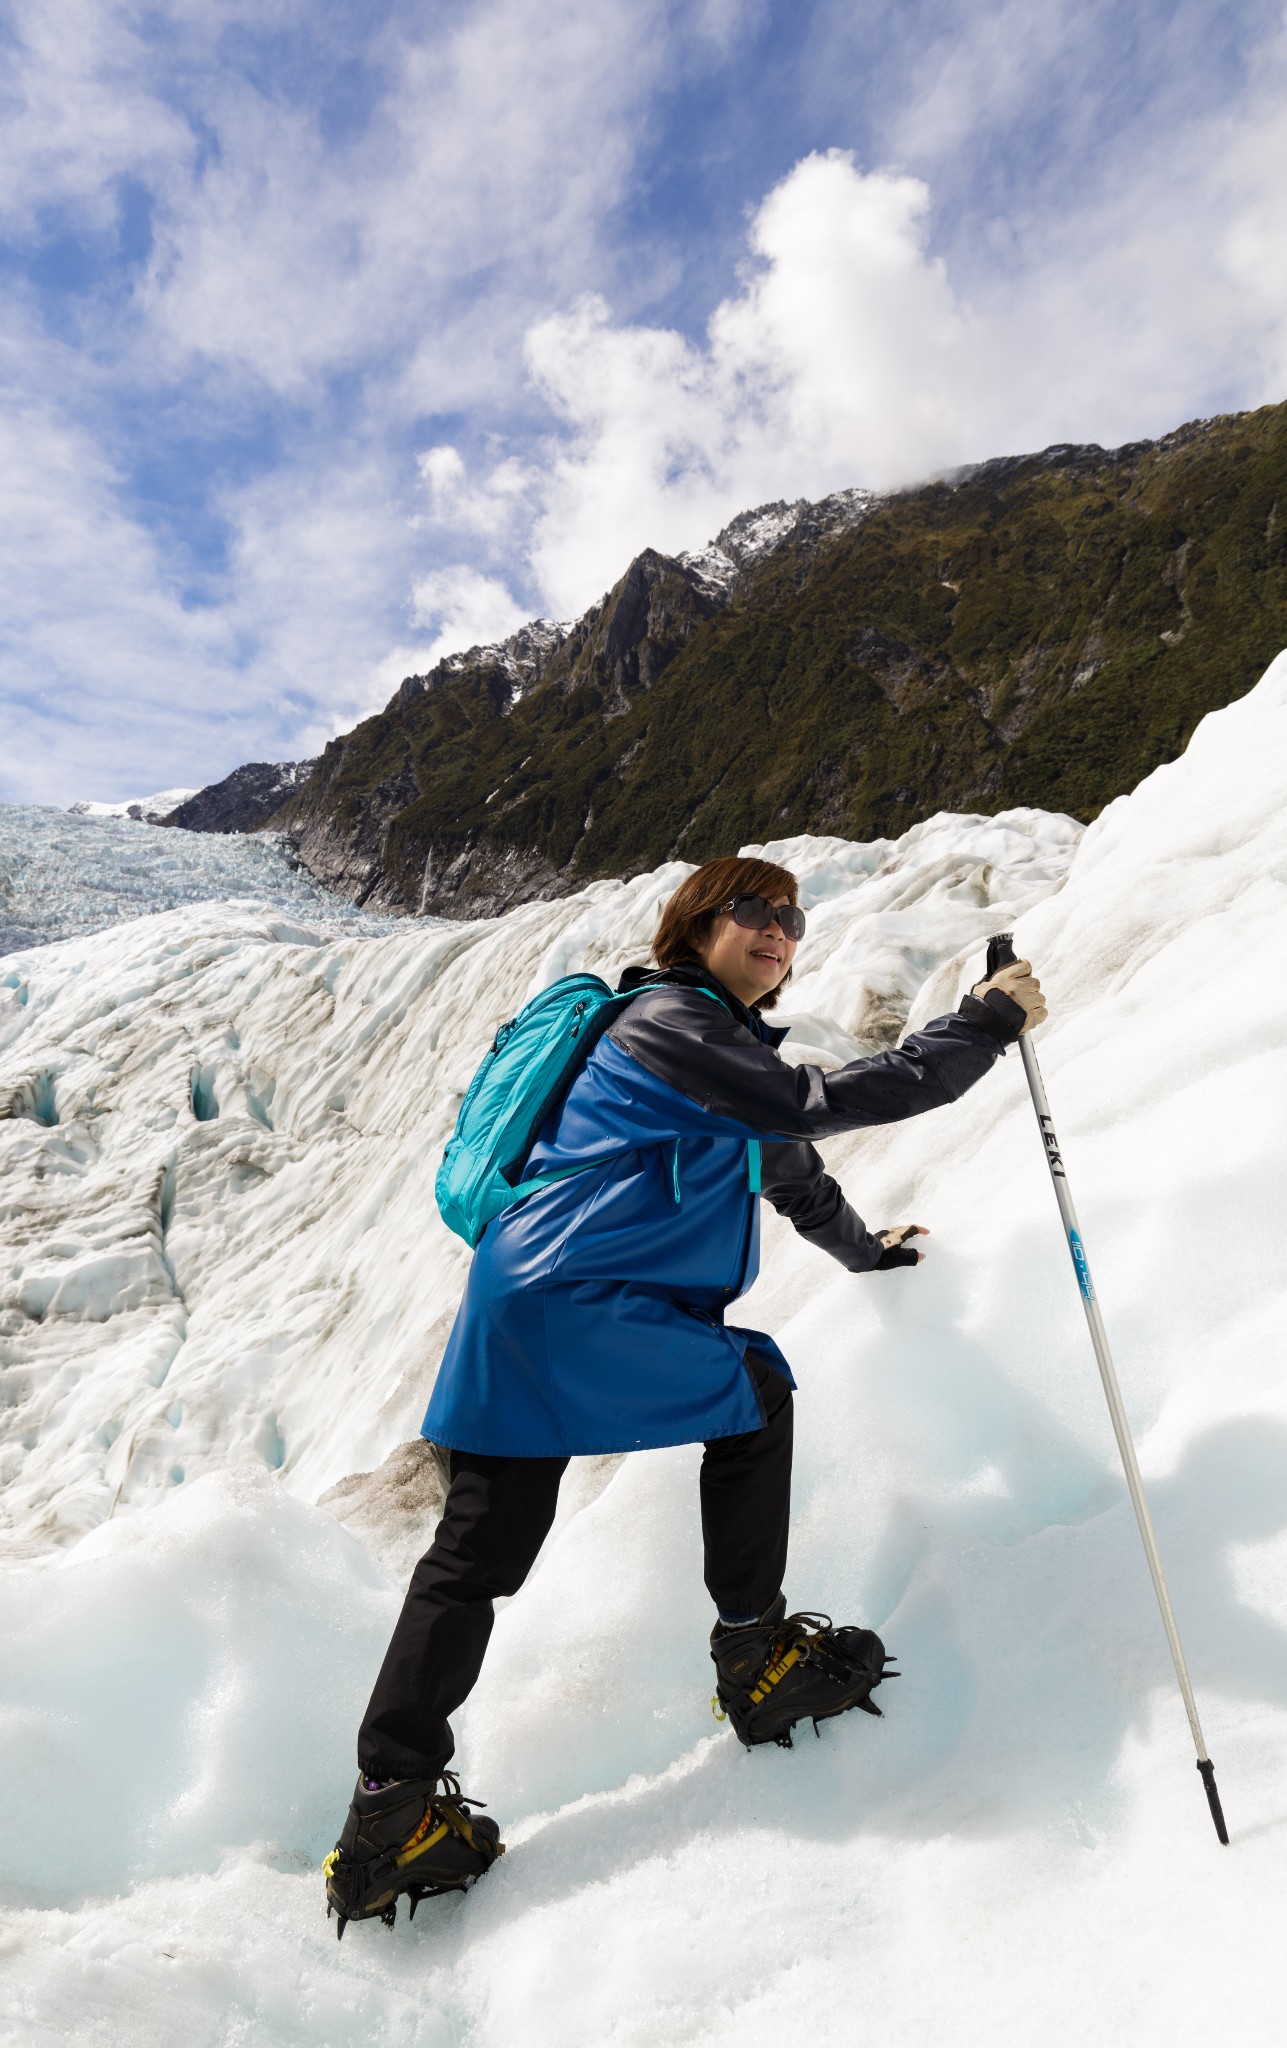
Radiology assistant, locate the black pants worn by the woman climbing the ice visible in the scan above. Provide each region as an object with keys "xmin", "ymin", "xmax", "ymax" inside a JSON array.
[{"xmin": 357, "ymin": 1352, "xmax": 791, "ymax": 1778}]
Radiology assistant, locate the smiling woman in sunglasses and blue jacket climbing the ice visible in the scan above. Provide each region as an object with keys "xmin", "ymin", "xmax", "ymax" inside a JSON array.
[{"xmin": 326, "ymin": 858, "xmax": 1045, "ymax": 1933}]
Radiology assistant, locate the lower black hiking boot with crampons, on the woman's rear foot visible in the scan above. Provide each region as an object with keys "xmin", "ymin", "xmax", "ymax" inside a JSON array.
[{"xmin": 322, "ymin": 1772, "xmax": 504, "ymax": 1939}]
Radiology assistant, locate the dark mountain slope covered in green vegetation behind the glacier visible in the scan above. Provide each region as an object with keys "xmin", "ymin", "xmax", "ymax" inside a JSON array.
[{"xmin": 275, "ymin": 406, "xmax": 1287, "ymax": 915}]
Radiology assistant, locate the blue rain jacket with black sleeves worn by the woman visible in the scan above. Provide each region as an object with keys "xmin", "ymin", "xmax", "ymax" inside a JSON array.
[{"xmin": 422, "ymin": 969, "xmax": 1023, "ymax": 1458}]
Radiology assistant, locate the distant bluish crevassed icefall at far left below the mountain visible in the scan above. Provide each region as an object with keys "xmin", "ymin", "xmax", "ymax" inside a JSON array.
[{"xmin": 0, "ymin": 791, "xmax": 389, "ymax": 958}]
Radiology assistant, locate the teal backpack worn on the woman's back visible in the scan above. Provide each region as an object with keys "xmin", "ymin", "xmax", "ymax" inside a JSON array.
[{"xmin": 434, "ymin": 975, "xmax": 733, "ymax": 1245}]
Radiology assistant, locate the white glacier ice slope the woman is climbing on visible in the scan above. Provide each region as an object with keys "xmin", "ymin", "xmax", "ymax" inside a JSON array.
[{"xmin": 0, "ymin": 659, "xmax": 1287, "ymax": 2048}]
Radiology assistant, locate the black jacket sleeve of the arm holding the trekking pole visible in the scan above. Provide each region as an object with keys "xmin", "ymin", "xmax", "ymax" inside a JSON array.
[{"xmin": 609, "ymin": 985, "xmax": 1023, "ymax": 1139}]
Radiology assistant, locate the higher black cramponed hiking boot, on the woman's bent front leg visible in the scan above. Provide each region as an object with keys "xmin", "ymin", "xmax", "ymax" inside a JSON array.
[{"xmin": 711, "ymin": 1593, "xmax": 898, "ymax": 1749}]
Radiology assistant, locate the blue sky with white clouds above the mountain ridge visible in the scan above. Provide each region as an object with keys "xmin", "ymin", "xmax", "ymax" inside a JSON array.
[{"xmin": 0, "ymin": 0, "xmax": 1287, "ymax": 803}]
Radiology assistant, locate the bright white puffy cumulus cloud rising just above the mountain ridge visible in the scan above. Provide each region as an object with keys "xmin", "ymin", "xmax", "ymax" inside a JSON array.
[{"xmin": 518, "ymin": 152, "xmax": 975, "ymax": 614}]
